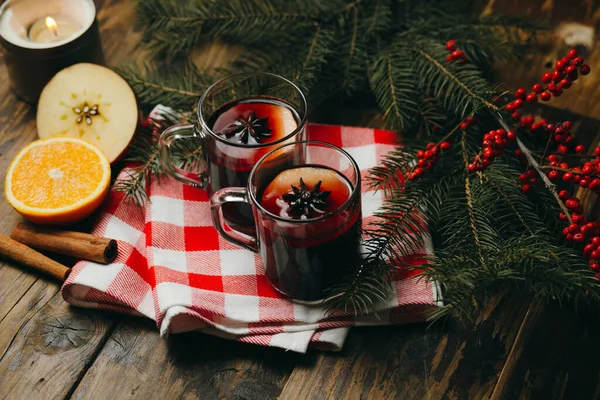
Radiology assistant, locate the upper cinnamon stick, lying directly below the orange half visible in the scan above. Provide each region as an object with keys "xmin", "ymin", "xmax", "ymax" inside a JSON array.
[{"xmin": 10, "ymin": 224, "xmax": 118, "ymax": 264}]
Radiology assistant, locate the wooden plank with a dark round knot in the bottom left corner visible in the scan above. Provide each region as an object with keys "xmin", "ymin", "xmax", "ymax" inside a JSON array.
[{"xmin": 0, "ymin": 279, "xmax": 116, "ymax": 399}]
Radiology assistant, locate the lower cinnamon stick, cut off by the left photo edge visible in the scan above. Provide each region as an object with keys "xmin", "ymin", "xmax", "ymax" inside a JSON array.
[{"xmin": 0, "ymin": 235, "xmax": 71, "ymax": 282}]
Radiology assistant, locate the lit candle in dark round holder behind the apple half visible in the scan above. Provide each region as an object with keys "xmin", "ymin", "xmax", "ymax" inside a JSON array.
[{"xmin": 0, "ymin": 0, "xmax": 104, "ymax": 104}]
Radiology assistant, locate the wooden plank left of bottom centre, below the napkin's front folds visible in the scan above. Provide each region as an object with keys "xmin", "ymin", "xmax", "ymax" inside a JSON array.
[{"xmin": 73, "ymin": 319, "xmax": 298, "ymax": 400}]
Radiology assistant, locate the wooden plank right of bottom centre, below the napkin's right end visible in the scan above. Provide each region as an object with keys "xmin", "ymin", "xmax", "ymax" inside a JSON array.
[{"xmin": 280, "ymin": 295, "xmax": 526, "ymax": 400}]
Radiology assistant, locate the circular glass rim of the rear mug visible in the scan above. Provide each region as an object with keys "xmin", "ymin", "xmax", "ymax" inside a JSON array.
[{"xmin": 196, "ymin": 71, "xmax": 308, "ymax": 149}]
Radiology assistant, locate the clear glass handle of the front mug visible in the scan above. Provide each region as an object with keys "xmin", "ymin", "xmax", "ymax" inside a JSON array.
[{"xmin": 210, "ymin": 187, "xmax": 258, "ymax": 253}]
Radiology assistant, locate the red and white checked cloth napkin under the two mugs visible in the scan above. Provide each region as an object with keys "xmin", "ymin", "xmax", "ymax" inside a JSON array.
[{"xmin": 63, "ymin": 107, "xmax": 439, "ymax": 352}]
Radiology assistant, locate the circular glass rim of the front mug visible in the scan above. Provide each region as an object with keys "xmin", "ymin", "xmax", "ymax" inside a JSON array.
[{"xmin": 246, "ymin": 140, "xmax": 361, "ymax": 224}]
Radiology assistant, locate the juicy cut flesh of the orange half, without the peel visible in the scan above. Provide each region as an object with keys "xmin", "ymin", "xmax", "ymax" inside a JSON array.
[{"xmin": 11, "ymin": 142, "xmax": 104, "ymax": 208}]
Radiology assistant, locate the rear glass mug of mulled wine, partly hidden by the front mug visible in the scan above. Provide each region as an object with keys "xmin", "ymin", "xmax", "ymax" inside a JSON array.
[{"xmin": 159, "ymin": 72, "xmax": 307, "ymax": 232}]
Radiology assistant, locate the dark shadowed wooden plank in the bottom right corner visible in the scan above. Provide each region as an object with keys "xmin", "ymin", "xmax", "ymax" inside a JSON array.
[{"xmin": 493, "ymin": 304, "xmax": 600, "ymax": 399}]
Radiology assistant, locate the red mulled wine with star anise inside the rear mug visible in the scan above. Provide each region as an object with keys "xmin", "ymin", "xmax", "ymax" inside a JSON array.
[{"xmin": 207, "ymin": 97, "xmax": 301, "ymax": 232}]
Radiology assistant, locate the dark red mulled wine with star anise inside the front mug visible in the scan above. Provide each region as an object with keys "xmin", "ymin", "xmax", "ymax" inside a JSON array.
[{"xmin": 257, "ymin": 165, "xmax": 361, "ymax": 301}]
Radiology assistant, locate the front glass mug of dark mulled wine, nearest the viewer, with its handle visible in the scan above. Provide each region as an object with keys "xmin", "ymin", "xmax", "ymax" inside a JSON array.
[{"xmin": 211, "ymin": 141, "xmax": 362, "ymax": 304}]
